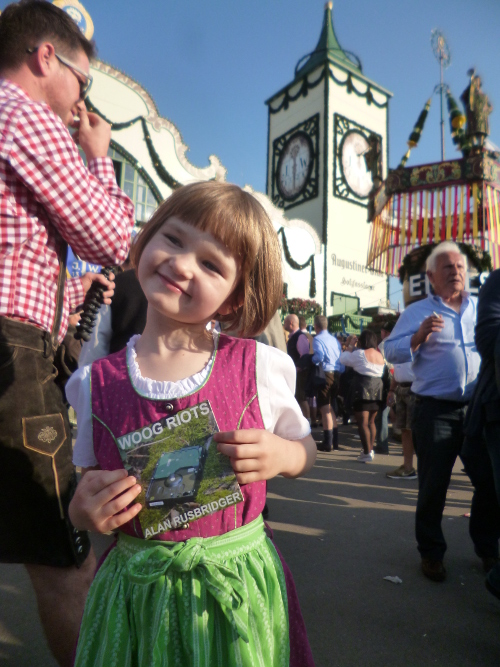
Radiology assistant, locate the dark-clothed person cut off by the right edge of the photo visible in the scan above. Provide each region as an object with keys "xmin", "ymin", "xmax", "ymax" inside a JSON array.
[{"xmin": 461, "ymin": 269, "xmax": 500, "ymax": 598}]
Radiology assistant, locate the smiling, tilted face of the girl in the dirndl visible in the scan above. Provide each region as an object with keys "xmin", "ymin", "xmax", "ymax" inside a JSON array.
[{"xmin": 138, "ymin": 217, "xmax": 240, "ymax": 324}]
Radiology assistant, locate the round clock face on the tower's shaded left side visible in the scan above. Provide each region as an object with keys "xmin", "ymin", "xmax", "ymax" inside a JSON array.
[{"xmin": 276, "ymin": 132, "xmax": 314, "ymax": 201}]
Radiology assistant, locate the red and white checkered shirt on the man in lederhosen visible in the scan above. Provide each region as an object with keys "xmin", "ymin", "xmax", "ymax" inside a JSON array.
[{"xmin": 0, "ymin": 79, "xmax": 134, "ymax": 341}]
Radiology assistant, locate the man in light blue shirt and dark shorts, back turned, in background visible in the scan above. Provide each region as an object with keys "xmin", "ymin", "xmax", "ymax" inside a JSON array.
[{"xmin": 312, "ymin": 315, "xmax": 344, "ymax": 452}]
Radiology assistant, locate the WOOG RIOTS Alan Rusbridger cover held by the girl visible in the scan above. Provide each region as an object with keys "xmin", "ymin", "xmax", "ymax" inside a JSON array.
[{"xmin": 117, "ymin": 400, "xmax": 243, "ymax": 539}]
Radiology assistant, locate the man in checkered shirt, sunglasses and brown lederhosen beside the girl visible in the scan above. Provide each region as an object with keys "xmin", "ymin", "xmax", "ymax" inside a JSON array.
[{"xmin": 0, "ymin": 0, "xmax": 134, "ymax": 665}]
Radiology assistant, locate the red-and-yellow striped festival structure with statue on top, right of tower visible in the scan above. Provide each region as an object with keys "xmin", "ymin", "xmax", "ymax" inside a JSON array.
[{"xmin": 365, "ymin": 31, "xmax": 500, "ymax": 305}]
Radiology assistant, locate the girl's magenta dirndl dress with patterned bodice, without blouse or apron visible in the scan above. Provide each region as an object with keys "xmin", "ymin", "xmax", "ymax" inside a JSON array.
[{"xmin": 85, "ymin": 335, "xmax": 314, "ymax": 667}]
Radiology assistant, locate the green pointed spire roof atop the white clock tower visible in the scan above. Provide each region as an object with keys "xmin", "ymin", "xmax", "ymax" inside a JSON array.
[{"xmin": 295, "ymin": 2, "xmax": 362, "ymax": 78}]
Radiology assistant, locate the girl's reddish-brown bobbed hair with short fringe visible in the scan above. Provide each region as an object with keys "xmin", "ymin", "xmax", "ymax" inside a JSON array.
[{"xmin": 131, "ymin": 181, "xmax": 283, "ymax": 338}]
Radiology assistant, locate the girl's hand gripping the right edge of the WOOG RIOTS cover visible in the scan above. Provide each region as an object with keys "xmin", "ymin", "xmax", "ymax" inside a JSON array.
[{"xmin": 214, "ymin": 428, "xmax": 317, "ymax": 484}]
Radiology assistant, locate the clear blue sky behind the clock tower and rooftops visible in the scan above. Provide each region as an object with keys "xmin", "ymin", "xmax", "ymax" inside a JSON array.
[{"xmin": 4, "ymin": 0, "xmax": 500, "ymax": 308}]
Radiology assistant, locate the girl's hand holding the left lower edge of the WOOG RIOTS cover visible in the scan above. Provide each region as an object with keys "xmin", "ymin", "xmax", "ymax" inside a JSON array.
[{"xmin": 69, "ymin": 470, "xmax": 142, "ymax": 533}]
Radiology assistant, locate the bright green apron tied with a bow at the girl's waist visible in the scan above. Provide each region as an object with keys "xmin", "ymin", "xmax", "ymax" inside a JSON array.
[{"xmin": 75, "ymin": 516, "xmax": 289, "ymax": 667}]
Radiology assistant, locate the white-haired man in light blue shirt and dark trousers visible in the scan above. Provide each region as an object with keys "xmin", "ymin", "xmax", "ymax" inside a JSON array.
[{"xmin": 384, "ymin": 242, "xmax": 480, "ymax": 582}]
